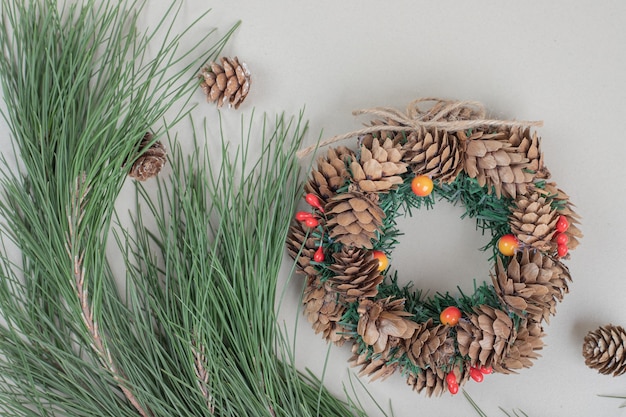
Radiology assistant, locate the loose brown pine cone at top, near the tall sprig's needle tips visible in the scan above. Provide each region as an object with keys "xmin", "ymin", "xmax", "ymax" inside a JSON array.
[{"xmin": 198, "ymin": 57, "xmax": 250, "ymax": 109}]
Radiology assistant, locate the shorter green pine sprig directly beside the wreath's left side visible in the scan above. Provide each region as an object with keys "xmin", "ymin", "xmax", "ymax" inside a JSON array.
[{"xmin": 129, "ymin": 115, "xmax": 364, "ymax": 417}]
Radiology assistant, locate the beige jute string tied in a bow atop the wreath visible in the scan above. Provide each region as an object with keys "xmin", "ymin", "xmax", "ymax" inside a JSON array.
[{"xmin": 296, "ymin": 97, "xmax": 543, "ymax": 158}]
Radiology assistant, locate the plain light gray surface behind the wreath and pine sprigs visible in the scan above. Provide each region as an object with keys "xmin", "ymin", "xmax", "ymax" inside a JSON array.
[{"xmin": 0, "ymin": 0, "xmax": 626, "ymax": 417}]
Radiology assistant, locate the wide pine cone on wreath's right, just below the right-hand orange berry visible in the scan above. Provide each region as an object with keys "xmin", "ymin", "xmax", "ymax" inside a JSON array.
[{"xmin": 491, "ymin": 248, "xmax": 571, "ymax": 322}]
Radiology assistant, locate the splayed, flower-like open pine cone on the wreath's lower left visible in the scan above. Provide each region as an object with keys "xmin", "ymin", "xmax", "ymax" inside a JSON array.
[{"xmin": 357, "ymin": 298, "xmax": 419, "ymax": 353}]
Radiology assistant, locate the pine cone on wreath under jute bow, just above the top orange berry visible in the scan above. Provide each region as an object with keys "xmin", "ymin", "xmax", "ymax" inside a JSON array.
[{"xmin": 403, "ymin": 129, "xmax": 463, "ymax": 183}]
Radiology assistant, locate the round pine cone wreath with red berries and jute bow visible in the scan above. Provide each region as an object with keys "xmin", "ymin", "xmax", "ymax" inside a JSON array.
[{"xmin": 287, "ymin": 98, "xmax": 582, "ymax": 396}]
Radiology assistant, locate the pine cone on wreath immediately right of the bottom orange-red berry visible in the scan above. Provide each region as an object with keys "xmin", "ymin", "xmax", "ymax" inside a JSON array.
[{"xmin": 456, "ymin": 305, "xmax": 516, "ymax": 367}]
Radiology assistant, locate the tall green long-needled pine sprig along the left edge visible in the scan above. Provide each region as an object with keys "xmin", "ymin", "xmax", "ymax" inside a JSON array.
[{"xmin": 0, "ymin": 0, "xmax": 234, "ymax": 417}]
